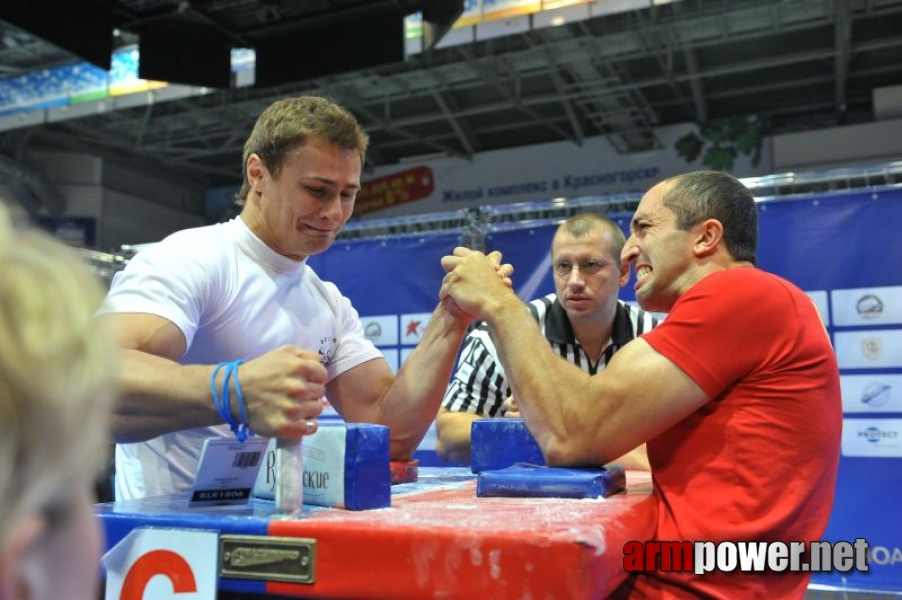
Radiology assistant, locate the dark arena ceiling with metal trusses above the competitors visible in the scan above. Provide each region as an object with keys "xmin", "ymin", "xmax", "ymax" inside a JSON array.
[{"xmin": 0, "ymin": 0, "xmax": 902, "ymax": 213}]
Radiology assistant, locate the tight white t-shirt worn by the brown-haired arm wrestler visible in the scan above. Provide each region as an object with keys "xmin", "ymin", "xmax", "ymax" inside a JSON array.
[{"xmin": 100, "ymin": 217, "xmax": 382, "ymax": 500}]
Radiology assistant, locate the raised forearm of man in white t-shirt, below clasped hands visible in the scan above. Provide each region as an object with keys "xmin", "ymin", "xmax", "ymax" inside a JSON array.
[{"xmin": 378, "ymin": 304, "xmax": 467, "ymax": 459}]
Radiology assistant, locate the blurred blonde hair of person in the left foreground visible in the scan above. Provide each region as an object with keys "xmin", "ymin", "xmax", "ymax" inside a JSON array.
[{"xmin": 0, "ymin": 206, "xmax": 116, "ymax": 552}]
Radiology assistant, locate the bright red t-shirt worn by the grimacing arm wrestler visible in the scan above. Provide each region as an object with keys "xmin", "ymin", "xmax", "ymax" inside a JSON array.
[{"xmin": 629, "ymin": 268, "xmax": 842, "ymax": 599}]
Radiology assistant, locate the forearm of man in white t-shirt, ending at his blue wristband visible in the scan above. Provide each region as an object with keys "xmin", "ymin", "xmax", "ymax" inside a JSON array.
[{"xmin": 112, "ymin": 350, "xmax": 222, "ymax": 443}]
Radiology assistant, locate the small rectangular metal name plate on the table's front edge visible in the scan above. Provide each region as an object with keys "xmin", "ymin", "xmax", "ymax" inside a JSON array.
[{"xmin": 219, "ymin": 535, "xmax": 316, "ymax": 583}]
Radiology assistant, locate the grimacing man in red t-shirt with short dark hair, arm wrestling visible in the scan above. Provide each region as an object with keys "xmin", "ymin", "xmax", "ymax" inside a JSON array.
[{"xmin": 441, "ymin": 171, "xmax": 842, "ymax": 598}]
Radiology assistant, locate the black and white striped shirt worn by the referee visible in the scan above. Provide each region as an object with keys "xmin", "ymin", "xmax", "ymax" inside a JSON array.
[{"xmin": 442, "ymin": 294, "xmax": 658, "ymax": 417}]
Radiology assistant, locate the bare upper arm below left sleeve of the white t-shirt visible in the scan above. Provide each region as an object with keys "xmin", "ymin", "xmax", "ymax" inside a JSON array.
[{"xmin": 98, "ymin": 313, "xmax": 187, "ymax": 361}]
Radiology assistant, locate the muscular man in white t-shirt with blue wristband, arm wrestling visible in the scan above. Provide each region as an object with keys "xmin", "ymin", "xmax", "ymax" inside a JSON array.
[{"xmin": 100, "ymin": 97, "xmax": 511, "ymax": 500}]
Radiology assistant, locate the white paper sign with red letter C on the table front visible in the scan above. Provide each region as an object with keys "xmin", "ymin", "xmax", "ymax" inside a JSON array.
[{"xmin": 103, "ymin": 527, "xmax": 219, "ymax": 600}]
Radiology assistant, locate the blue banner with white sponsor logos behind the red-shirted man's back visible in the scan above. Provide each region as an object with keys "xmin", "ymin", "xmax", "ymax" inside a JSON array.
[{"xmin": 758, "ymin": 190, "xmax": 902, "ymax": 591}]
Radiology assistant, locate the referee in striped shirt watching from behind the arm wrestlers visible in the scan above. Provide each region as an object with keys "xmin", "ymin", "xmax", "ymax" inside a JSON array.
[{"xmin": 436, "ymin": 213, "xmax": 658, "ymax": 470}]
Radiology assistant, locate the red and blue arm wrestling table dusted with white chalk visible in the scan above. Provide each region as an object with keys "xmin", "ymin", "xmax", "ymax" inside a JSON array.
[{"xmin": 95, "ymin": 467, "xmax": 656, "ymax": 599}]
